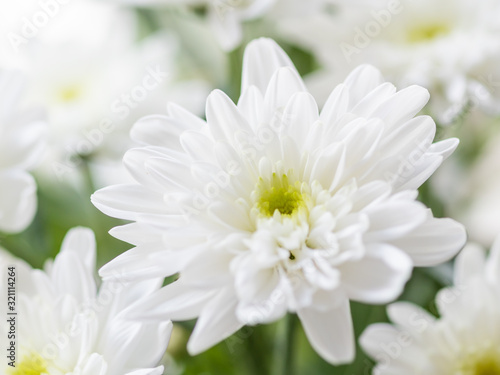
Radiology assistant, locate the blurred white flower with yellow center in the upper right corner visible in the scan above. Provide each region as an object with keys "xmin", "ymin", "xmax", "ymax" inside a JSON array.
[{"xmin": 282, "ymin": 0, "xmax": 500, "ymax": 122}]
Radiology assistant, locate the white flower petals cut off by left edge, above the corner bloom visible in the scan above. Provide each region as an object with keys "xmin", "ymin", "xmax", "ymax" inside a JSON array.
[{"xmin": 0, "ymin": 71, "xmax": 46, "ymax": 232}]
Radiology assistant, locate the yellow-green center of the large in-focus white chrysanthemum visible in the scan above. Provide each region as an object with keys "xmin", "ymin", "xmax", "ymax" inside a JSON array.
[{"xmin": 257, "ymin": 173, "xmax": 304, "ymax": 217}]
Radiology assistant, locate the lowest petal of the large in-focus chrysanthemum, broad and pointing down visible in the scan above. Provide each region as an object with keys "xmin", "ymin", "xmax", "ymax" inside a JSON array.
[{"xmin": 298, "ymin": 299, "xmax": 355, "ymax": 364}]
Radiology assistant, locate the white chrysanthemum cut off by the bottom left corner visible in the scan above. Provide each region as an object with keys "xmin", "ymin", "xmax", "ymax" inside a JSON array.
[{"xmin": 0, "ymin": 228, "xmax": 172, "ymax": 375}]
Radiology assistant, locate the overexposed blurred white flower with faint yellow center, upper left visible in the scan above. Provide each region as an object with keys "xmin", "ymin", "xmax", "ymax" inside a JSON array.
[{"xmin": 0, "ymin": 0, "xmax": 209, "ymax": 182}]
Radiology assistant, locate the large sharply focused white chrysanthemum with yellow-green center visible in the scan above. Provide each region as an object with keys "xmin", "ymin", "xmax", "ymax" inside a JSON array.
[{"xmin": 92, "ymin": 39, "xmax": 465, "ymax": 363}]
